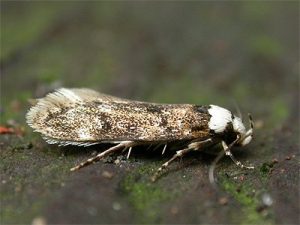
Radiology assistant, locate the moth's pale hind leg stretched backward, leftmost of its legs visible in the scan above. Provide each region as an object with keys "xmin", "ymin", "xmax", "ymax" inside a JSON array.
[{"xmin": 70, "ymin": 141, "xmax": 134, "ymax": 171}]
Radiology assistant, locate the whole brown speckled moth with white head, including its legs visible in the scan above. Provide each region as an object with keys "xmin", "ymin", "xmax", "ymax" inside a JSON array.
[{"xmin": 26, "ymin": 88, "xmax": 253, "ymax": 178}]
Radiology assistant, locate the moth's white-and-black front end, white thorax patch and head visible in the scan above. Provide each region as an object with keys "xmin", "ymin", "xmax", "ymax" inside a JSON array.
[{"xmin": 208, "ymin": 105, "xmax": 253, "ymax": 146}]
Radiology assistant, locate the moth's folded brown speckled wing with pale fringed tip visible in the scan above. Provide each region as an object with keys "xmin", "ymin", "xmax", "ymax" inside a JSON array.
[{"xmin": 27, "ymin": 89, "xmax": 210, "ymax": 142}]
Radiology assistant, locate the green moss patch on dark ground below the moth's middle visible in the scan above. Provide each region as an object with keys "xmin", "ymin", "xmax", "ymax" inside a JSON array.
[{"xmin": 121, "ymin": 166, "xmax": 173, "ymax": 223}]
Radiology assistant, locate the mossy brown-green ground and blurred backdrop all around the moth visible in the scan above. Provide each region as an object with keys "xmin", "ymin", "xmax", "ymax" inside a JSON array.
[{"xmin": 0, "ymin": 1, "xmax": 300, "ymax": 224}]
